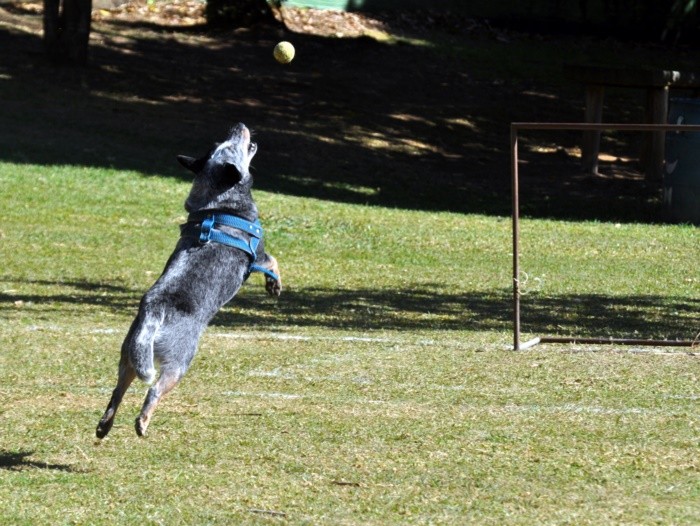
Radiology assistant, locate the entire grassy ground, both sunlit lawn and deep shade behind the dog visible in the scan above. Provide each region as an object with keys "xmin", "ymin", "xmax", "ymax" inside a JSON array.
[{"xmin": 0, "ymin": 2, "xmax": 700, "ymax": 526}]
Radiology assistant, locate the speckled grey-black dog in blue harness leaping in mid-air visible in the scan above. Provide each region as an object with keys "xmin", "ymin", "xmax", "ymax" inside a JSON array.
[{"xmin": 96, "ymin": 123, "xmax": 282, "ymax": 439}]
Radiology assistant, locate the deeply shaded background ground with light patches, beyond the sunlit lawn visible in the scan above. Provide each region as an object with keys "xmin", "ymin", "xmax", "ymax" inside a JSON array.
[{"xmin": 0, "ymin": 0, "xmax": 695, "ymax": 221}]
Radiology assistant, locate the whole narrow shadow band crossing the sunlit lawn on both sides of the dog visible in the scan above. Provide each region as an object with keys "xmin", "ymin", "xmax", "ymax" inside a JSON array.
[{"xmin": 0, "ymin": 279, "xmax": 700, "ymax": 340}]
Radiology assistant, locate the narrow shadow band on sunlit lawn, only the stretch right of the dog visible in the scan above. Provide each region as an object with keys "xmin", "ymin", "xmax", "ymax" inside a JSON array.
[{"xmin": 212, "ymin": 287, "xmax": 700, "ymax": 339}]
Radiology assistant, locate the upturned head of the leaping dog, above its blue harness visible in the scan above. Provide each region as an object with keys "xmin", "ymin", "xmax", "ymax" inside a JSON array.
[{"xmin": 177, "ymin": 123, "xmax": 258, "ymax": 212}]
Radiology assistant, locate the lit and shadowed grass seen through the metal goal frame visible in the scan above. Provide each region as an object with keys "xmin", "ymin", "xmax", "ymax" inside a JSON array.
[{"xmin": 522, "ymin": 221, "xmax": 700, "ymax": 340}]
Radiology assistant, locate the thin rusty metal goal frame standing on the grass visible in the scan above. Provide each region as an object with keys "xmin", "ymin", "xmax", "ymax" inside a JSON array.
[{"xmin": 510, "ymin": 122, "xmax": 700, "ymax": 351}]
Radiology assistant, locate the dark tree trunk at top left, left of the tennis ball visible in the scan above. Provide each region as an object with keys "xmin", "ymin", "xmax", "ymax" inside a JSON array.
[{"xmin": 44, "ymin": 0, "xmax": 92, "ymax": 65}]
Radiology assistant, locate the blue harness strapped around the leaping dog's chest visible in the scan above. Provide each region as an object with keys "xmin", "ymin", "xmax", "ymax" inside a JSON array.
[{"xmin": 180, "ymin": 212, "xmax": 279, "ymax": 281}]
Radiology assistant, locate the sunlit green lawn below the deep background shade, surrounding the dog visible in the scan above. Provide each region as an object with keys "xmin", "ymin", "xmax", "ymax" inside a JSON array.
[{"xmin": 0, "ymin": 163, "xmax": 700, "ymax": 525}]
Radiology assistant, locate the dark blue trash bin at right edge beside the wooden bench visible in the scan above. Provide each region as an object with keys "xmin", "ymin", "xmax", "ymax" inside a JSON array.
[{"xmin": 664, "ymin": 99, "xmax": 700, "ymax": 225}]
